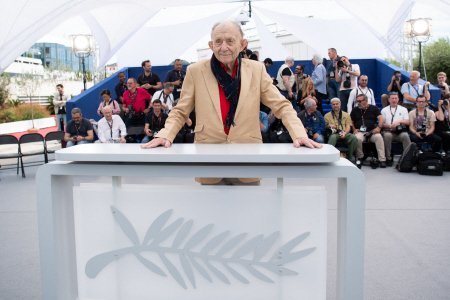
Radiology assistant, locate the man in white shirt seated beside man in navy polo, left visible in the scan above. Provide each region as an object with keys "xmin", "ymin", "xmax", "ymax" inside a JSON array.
[{"xmin": 98, "ymin": 105, "xmax": 127, "ymax": 143}]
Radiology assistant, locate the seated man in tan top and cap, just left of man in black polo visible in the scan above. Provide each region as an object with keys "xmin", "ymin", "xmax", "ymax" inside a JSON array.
[{"xmin": 324, "ymin": 97, "xmax": 358, "ymax": 160}]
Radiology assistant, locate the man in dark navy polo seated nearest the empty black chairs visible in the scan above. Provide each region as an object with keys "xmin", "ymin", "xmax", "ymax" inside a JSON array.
[{"xmin": 64, "ymin": 107, "xmax": 94, "ymax": 148}]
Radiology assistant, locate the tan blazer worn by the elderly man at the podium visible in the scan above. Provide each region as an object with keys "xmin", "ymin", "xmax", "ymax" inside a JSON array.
[{"xmin": 157, "ymin": 59, "xmax": 307, "ymax": 184}]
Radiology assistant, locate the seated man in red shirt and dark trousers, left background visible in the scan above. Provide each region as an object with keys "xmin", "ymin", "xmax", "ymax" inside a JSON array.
[{"xmin": 123, "ymin": 78, "xmax": 152, "ymax": 128}]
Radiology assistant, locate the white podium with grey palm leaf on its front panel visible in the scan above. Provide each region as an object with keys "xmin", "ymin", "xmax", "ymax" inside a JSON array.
[{"xmin": 36, "ymin": 144, "xmax": 365, "ymax": 300}]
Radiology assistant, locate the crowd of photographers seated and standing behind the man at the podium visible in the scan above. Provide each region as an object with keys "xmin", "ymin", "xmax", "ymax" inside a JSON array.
[{"xmin": 54, "ymin": 48, "xmax": 450, "ymax": 168}]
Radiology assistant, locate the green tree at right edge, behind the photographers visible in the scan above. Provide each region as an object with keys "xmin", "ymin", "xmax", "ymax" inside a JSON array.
[{"xmin": 414, "ymin": 37, "xmax": 450, "ymax": 85}]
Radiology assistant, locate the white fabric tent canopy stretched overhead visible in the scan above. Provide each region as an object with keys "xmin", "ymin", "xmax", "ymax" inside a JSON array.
[{"xmin": 0, "ymin": 0, "xmax": 450, "ymax": 72}]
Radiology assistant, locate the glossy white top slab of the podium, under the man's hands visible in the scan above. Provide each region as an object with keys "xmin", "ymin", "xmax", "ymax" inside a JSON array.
[{"xmin": 56, "ymin": 144, "xmax": 340, "ymax": 164}]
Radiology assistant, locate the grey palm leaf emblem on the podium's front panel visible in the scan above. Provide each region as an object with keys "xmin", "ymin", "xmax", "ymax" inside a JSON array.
[{"xmin": 85, "ymin": 206, "xmax": 316, "ymax": 289}]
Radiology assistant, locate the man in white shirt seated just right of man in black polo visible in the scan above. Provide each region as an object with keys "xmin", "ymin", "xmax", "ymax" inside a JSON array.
[{"xmin": 381, "ymin": 92, "xmax": 411, "ymax": 167}]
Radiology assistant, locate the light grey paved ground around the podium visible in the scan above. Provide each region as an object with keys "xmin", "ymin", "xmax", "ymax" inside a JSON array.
[{"xmin": 0, "ymin": 154, "xmax": 450, "ymax": 300}]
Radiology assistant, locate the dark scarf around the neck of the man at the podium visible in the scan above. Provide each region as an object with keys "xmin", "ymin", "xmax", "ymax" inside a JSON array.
[{"xmin": 211, "ymin": 54, "xmax": 242, "ymax": 128}]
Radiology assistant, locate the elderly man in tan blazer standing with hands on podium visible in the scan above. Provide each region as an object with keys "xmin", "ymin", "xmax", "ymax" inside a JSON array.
[{"xmin": 142, "ymin": 21, "xmax": 322, "ymax": 184}]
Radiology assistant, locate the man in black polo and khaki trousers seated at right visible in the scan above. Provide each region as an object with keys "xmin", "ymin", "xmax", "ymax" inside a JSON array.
[{"xmin": 350, "ymin": 94, "xmax": 386, "ymax": 168}]
